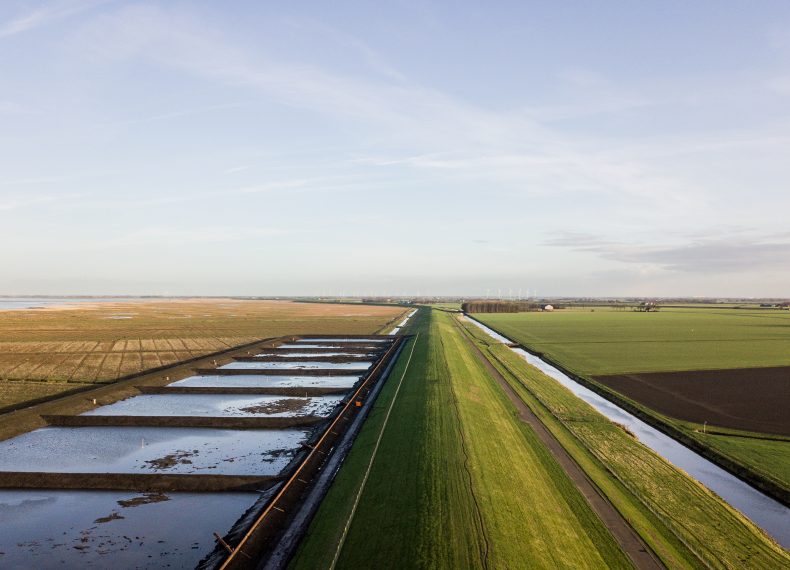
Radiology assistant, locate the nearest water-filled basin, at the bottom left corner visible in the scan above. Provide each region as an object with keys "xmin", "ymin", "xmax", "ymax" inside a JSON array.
[{"xmin": 0, "ymin": 489, "xmax": 259, "ymax": 570}]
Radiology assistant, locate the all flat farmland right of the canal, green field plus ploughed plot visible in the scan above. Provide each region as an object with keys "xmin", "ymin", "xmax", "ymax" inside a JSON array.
[{"xmin": 475, "ymin": 306, "xmax": 790, "ymax": 500}]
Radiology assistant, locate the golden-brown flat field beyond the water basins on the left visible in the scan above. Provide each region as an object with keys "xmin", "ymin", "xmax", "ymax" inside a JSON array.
[{"xmin": 0, "ymin": 299, "xmax": 404, "ymax": 408}]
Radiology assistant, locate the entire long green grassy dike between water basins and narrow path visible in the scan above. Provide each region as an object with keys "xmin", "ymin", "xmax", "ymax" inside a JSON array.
[{"xmin": 293, "ymin": 311, "xmax": 630, "ymax": 568}]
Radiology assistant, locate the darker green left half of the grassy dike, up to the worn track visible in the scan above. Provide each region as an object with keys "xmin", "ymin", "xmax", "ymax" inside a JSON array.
[{"xmin": 291, "ymin": 311, "xmax": 485, "ymax": 569}]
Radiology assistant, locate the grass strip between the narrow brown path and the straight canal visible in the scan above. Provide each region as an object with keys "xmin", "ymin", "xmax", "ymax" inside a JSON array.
[{"xmin": 458, "ymin": 320, "xmax": 790, "ymax": 568}]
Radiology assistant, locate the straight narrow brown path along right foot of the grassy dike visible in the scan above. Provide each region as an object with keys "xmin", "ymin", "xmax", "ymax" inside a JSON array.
[{"xmin": 453, "ymin": 319, "xmax": 664, "ymax": 570}]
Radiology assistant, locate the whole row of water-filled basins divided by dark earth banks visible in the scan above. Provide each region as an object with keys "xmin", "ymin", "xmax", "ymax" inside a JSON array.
[{"xmin": 0, "ymin": 330, "xmax": 398, "ymax": 568}]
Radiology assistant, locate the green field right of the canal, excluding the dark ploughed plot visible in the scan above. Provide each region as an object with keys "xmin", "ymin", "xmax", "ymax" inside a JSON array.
[{"xmin": 476, "ymin": 309, "xmax": 790, "ymax": 487}]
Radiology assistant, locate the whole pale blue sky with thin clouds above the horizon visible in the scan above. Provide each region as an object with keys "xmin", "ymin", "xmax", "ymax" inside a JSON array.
[{"xmin": 0, "ymin": 0, "xmax": 790, "ymax": 297}]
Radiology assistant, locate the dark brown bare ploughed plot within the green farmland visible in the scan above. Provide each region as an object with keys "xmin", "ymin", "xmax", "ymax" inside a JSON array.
[{"xmin": 594, "ymin": 366, "xmax": 790, "ymax": 435}]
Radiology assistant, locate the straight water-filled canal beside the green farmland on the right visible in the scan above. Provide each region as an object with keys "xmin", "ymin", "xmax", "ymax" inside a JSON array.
[{"xmin": 464, "ymin": 316, "xmax": 790, "ymax": 549}]
